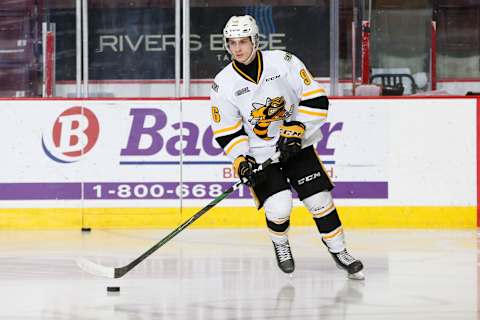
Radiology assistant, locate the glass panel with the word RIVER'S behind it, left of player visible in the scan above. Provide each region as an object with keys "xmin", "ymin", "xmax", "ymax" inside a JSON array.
[{"xmin": 88, "ymin": 0, "xmax": 175, "ymax": 97}]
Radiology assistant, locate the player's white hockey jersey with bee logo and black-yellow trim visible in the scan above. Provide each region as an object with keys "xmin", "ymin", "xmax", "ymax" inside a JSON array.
[{"xmin": 210, "ymin": 50, "xmax": 327, "ymax": 162}]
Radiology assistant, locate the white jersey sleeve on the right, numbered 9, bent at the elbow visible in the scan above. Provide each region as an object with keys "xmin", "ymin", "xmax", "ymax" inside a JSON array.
[{"xmin": 289, "ymin": 55, "xmax": 328, "ymax": 147}]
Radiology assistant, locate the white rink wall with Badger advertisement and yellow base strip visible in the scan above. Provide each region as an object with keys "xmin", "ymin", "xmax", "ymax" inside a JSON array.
[{"xmin": 0, "ymin": 97, "xmax": 479, "ymax": 229}]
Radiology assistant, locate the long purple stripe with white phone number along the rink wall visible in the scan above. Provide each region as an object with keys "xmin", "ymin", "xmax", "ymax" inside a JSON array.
[{"xmin": 0, "ymin": 181, "xmax": 388, "ymax": 200}]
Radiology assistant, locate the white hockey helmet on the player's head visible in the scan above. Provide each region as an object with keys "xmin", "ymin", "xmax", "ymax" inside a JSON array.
[{"xmin": 223, "ymin": 15, "xmax": 259, "ymax": 54}]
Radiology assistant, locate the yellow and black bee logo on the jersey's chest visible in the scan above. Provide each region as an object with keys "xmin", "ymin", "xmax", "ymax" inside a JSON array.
[{"xmin": 248, "ymin": 97, "xmax": 293, "ymax": 140}]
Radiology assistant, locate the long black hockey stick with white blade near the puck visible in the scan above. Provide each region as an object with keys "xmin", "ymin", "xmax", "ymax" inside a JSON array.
[{"xmin": 76, "ymin": 153, "xmax": 279, "ymax": 278}]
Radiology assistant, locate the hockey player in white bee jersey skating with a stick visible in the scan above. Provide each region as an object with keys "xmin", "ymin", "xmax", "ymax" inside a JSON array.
[{"xmin": 210, "ymin": 15, "xmax": 363, "ymax": 279}]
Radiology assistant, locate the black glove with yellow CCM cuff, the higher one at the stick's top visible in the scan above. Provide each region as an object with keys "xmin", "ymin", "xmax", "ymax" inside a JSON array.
[{"xmin": 277, "ymin": 121, "xmax": 305, "ymax": 162}]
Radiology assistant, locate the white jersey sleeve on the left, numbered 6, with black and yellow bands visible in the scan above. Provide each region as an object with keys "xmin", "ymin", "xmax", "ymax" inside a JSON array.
[{"xmin": 210, "ymin": 79, "xmax": 249, "ymax": 160}]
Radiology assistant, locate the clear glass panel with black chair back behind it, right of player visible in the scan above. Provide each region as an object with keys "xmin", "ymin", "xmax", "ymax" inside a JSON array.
[{"xmin": 370, "ymin": 0, "xmax": 432, "ymax": 95}]
